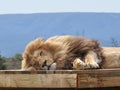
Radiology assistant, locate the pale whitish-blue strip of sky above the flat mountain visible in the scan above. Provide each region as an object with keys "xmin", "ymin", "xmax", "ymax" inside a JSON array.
[{"xmin": 0, "ymin": 0, "xmax": 120, "ymax": 14}]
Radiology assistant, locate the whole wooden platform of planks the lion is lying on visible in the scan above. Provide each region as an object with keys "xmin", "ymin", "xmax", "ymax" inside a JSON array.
[{"xmin": 0, "ymin": 69, "xmax": 120, "ymax": 88}]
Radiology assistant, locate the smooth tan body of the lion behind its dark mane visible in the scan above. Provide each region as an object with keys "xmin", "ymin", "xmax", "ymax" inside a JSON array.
[{"xmin": 101, "ymin": 47, "xmax": 120, "ymax": 69}]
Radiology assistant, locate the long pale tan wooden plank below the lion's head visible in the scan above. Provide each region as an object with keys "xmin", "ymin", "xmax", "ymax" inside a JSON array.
[{"xmin": 0, "ymin": 71, "xmax": 77, "ymax": 88}]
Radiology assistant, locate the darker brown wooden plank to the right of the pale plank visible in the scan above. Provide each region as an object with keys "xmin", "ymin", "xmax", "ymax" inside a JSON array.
[{"xmin": 77, "ymin": 70, "xmax": 120, "ymax": 88}]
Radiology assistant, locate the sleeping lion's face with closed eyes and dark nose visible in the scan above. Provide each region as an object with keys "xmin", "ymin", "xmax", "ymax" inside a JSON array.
[{"xmin": 31, "ymin": 49, "xmax": 54, "ymax": 70}]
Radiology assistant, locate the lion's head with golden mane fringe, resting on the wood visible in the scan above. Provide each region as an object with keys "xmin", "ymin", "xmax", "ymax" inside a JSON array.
[{"xmin": 22, "ymin": 39, "xmax": 54, "ymax": 70}]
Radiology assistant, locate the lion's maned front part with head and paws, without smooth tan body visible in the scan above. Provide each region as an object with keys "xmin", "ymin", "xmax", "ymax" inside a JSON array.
[{"xmin": 22, "ymin": 35, "xmax": 103, "ymax": 71}]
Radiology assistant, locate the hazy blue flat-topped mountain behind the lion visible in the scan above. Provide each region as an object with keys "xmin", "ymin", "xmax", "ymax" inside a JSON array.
[{"xmin": 0, "ymin": 13, "xmax": 120, "ymax": 57}]
